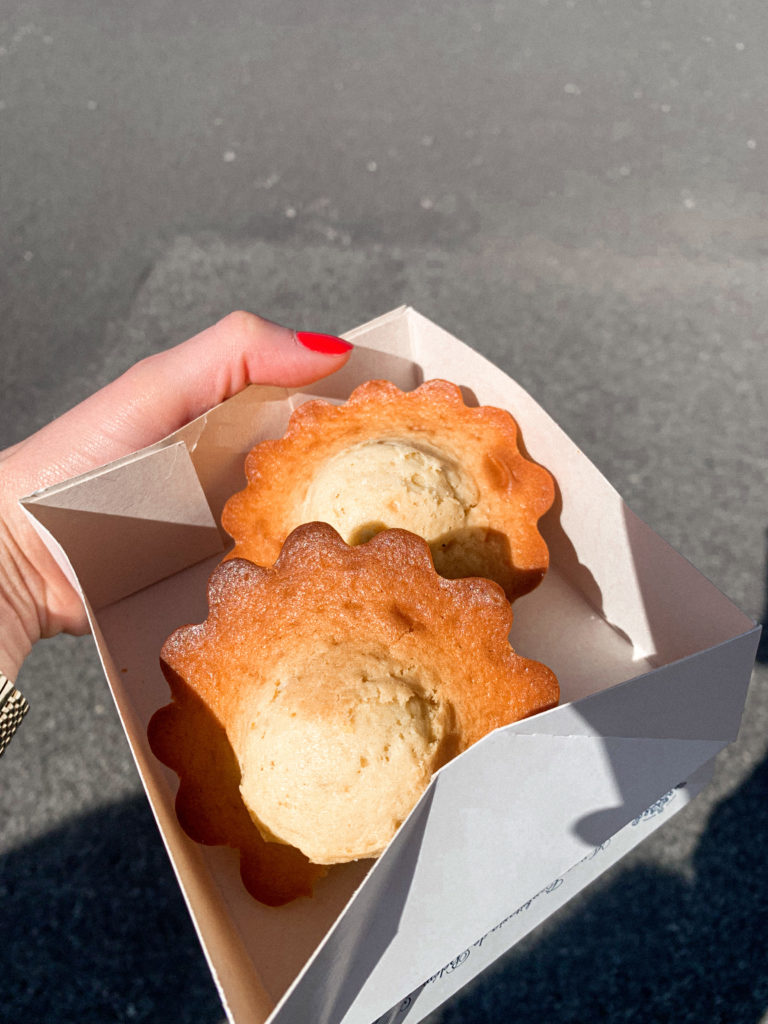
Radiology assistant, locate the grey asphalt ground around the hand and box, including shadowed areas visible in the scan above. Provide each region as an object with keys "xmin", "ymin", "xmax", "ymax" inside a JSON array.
[{"xmin": 0, "ymin": 0, "xmax": 768, "ymax": 1024}]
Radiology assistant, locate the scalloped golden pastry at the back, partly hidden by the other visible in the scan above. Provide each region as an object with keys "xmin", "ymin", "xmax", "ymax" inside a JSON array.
[{"xmin": 222, "ymin": 380, "xmax": 554, "ymax": 601}]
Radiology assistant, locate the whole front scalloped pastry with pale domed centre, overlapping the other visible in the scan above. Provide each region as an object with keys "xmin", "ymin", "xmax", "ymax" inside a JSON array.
[{"xmin": 150, "ymin": 522, "xmax": 559, "ymax": 902}]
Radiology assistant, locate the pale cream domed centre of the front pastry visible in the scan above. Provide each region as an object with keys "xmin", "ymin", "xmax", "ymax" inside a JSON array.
[{"xmin": 233, "ymin": 648, "xmax": 449, "ymax": 864}]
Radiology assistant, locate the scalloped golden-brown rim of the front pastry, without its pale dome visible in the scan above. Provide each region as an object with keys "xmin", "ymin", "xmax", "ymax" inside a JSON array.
[{"xmin": 150, "ymin": 523, "xmax": 559, "ymax": 903}]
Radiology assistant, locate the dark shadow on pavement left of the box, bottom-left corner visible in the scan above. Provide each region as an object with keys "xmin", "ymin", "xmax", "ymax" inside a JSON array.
[{"xmin": 0, "ymin": 796, "xmax": 224, "ymax": 1024}]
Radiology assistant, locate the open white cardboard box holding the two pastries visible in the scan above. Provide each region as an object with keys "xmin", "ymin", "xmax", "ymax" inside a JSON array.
[{"xmin": 23, "ymin": 308, "xmax": 759, "ymax": 1024}]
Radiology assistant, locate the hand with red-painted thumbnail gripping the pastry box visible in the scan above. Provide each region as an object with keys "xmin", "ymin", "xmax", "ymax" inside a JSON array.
[{"xmin": 0, "ymin": 311, "xmax": 349, "ymax": 679}]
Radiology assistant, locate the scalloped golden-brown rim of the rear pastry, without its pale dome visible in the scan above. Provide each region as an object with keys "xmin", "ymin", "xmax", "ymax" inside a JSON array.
[{"xmin": 222, "ymin": 380, "xmax": 554, "ymax": 601}]
